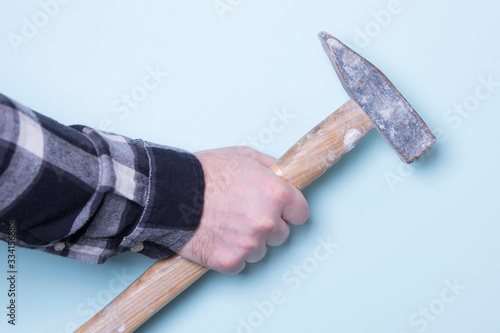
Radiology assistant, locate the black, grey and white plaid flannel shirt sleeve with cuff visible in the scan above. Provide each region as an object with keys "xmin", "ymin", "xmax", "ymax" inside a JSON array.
[{"xmin": 0, "ymin": 95, "xmax": 205, "ymax": 263}]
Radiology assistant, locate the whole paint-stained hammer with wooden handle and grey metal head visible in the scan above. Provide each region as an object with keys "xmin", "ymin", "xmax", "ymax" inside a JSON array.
[{"xmin": 76, "ymin": 32, "xmax": 436, "ymax": 333}]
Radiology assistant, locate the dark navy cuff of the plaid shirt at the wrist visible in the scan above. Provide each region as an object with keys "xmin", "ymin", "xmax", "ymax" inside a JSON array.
[{"xmin": 135, "ymin": 142, "xmax": 205, "ymax": 259}]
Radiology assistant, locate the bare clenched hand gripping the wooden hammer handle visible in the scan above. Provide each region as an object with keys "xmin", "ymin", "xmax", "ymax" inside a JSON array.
[{"xmin": 178, "ymin": 147, "xmax": 309, "ymax": 274}]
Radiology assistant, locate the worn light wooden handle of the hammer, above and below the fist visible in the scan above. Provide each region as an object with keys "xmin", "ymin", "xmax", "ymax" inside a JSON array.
[{"xmin": 76, "ymin": 100, "xmax": 373, "ymax": 333}]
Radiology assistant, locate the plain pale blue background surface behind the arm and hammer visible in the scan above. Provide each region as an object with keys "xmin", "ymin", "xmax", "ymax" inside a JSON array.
[{"xmin": 0, "ymin": 0, "xmax": 500, "ymax": 333}]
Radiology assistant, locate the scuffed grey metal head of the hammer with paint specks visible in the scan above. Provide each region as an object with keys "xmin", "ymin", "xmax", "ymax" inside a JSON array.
[{"xmin": 319, "ymin": 32, "xmax": 436, "ymax": 163}]
